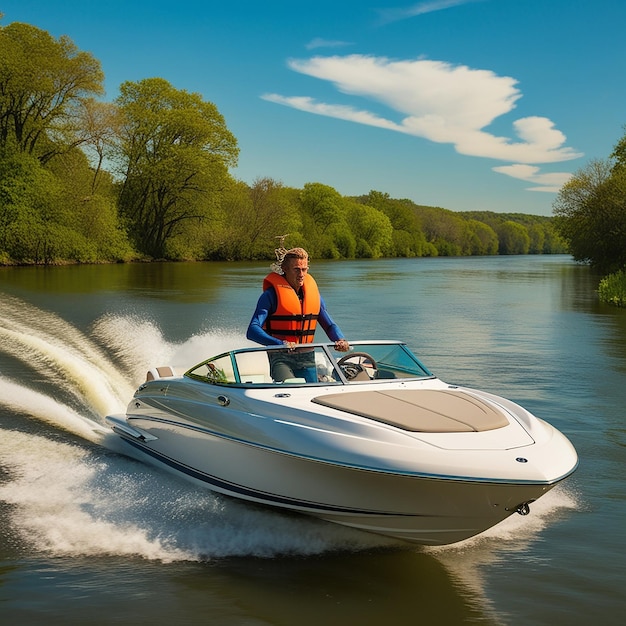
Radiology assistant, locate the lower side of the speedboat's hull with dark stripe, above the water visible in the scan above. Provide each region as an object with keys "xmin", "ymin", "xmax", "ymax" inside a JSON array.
[{"xmin": 109, "ymin": 416, "xmax": 565, "ymax": 545}]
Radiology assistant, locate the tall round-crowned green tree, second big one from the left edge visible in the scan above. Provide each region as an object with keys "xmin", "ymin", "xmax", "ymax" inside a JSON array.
[{"xmin": 117, "ymin": 78, "xmax": 239, "ymax": 258}]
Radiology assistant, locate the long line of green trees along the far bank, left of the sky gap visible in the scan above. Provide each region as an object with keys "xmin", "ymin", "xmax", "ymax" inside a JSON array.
[{"xmin": 0, "ymin": 16, "xmax": 567, "ymax": 264}]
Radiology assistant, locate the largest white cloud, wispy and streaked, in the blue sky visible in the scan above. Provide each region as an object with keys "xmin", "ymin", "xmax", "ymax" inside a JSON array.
[{"xmin": 262, "ymin": 54, "xmax": 582, "ymax": 190}]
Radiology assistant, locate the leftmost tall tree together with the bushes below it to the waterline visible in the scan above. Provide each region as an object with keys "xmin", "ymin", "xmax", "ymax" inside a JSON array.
[{"xmin": 0, "ymin": 23, "xmax": 129, "ymax": 263}]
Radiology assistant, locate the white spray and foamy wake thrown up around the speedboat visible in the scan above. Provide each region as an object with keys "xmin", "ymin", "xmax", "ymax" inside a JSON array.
[{"xmin": 0, "ymin": 296, "xmax": 575, "ymax": 566}]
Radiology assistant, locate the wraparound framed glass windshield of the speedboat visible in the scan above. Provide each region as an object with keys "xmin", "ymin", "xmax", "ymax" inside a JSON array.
[{"xmin": 185, "ymin": 342, "xmax": 432, "ymax": 386}]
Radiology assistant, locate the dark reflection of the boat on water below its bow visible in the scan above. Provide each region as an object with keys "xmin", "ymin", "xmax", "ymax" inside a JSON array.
[{"xmin": 193, "ymin": 551, "xmax": 496, "ymax": 626}]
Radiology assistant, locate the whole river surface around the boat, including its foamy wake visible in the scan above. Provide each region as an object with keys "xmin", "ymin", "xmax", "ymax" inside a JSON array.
[{"xmin": 0, "ymin": 256, "xmax": 626, "ymax": 626}]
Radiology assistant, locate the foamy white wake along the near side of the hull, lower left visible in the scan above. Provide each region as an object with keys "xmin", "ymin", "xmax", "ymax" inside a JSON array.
[{"xmin": 0, "ymin": 431, "xmax": 388, "ymax": 562}]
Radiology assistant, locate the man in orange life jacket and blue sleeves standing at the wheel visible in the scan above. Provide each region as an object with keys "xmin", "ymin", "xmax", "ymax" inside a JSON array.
[{"xmin": 246, "ymin": 248, "xmax": 350, "ymax": 382}]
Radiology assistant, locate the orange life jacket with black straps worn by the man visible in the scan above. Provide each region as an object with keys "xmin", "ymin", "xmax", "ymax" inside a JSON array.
[{"xmin": 263, "ymin": 272, "xmax": 321, "ymax": 343}]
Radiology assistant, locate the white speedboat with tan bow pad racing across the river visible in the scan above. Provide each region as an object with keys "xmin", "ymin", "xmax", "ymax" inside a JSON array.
[{"xmin": 107, "ymin": 341, "xmax": 578, "ymax": 545}]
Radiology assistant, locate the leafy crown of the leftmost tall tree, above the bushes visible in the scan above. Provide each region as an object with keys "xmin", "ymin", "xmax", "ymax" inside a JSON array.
[{"xmin": 0, "ymin": 22, "xmax": 104, "ymax": 164}]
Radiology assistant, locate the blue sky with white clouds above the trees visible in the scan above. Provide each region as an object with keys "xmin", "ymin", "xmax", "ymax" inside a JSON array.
[{"xmin": 0, "ymin": 0, "xmax": 626, "ymax": 215}]
